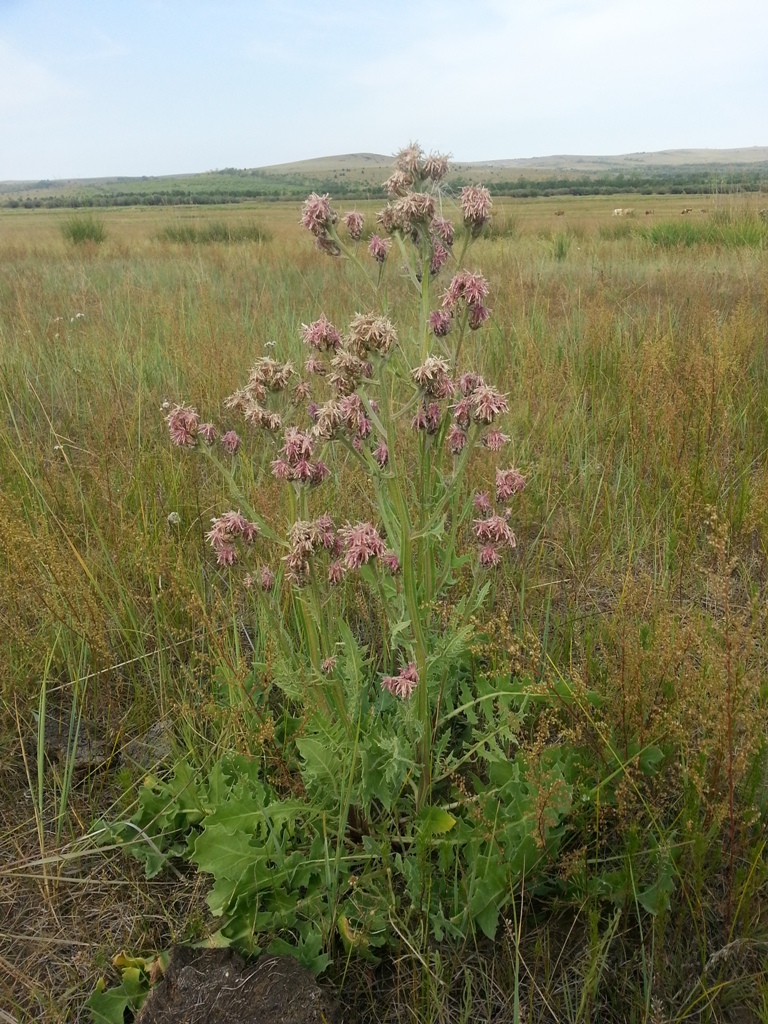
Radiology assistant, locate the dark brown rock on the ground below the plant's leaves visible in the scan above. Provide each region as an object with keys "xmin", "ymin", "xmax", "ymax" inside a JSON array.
[{"xmin": 136, "ymin": 946, "xmax": 341, "ymax": 1024}]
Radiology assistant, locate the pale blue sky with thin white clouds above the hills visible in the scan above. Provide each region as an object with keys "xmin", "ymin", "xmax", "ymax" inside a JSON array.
[{"xmin": 0, "ymin": 0, "xmax": 768, "ymax": 180}]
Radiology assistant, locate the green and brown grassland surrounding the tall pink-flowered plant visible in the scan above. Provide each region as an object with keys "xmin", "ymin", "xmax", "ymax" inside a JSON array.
[{"xmin": 0, "ymin": 188, "xmax": 768, "ymax": 1024}]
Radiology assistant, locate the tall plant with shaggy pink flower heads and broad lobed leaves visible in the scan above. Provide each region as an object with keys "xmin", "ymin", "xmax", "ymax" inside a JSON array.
[{"xmin": 145, "ymin": 144, "xmax": 567, "ymax": 962}]
